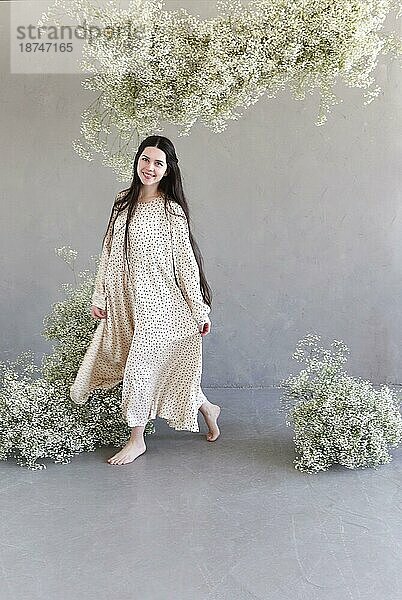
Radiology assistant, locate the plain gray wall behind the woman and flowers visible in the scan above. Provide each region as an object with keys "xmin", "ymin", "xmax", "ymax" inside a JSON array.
[{"xmin": 0, "ymin": 0, "xmax": 402, "ymax": 387}]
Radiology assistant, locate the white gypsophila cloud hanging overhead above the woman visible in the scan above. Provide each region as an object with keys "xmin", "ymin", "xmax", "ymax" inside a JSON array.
[{"xmin": 38, "ymin": 0, "xmax": 402, "ymax": 181}]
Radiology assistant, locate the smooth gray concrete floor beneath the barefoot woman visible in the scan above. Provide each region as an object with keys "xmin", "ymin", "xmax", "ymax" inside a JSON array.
[{"xmin": 0, "ymin": 388, "xmax": 402, "ymax": 600}]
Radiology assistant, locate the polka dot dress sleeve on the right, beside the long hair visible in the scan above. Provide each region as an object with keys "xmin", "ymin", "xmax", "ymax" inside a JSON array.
[{"xmin": 171, "ymin": 204, "xmax": 211, "ymax": 328}]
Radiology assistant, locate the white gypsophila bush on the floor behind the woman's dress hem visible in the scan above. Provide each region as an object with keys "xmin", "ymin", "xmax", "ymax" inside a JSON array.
[{"xmin": 0, "ymin": 247, "xmax": 155, "ymax": 470}]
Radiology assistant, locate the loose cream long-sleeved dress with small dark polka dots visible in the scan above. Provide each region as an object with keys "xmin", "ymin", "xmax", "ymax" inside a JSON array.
[{"xmin": 70, "ymin": 195, "xmax": 210, "ymax": 431}]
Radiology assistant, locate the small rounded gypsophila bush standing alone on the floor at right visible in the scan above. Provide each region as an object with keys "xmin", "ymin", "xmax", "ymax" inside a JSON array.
[{"xmin": 279, "ymin": 334, "xmax": 402, "ymax": 473}]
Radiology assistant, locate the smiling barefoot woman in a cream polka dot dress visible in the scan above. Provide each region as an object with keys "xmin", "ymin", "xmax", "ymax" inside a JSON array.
[{"xmin": 70, "ymin": 136, "xmax": 220, "ymax": 464}]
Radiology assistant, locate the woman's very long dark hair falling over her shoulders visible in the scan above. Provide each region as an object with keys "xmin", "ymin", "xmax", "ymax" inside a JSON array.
[{"xmin": 103, "ymin": 135, "xmax": 212, "ymax": 307}]
